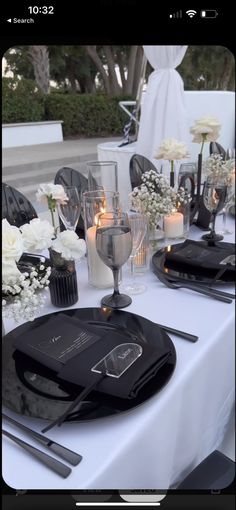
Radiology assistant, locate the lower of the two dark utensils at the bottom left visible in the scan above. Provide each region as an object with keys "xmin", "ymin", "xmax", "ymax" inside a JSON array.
[{"xmin": 2, "ymin": 429, "xmax": 71, "ymax": 478}]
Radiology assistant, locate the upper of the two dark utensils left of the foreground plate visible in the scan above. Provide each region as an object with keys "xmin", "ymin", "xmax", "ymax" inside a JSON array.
[{"xmin": 2, "ymin": 413, "xmax": 83, "ymax": 466}]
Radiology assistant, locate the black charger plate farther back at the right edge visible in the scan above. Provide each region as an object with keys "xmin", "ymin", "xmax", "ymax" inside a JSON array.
[{"xmin": 152, "ymin": 241, "xmax": 235, "ymax": 285}]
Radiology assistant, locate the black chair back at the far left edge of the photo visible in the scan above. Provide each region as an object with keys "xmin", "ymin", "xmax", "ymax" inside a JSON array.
[{"xmin": 2, "ymin": 183, "xmax": 38, "ymax": 227}]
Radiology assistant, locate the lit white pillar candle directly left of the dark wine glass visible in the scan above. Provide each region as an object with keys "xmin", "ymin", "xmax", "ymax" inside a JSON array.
[{"xmin": 87, "ymin": 226, "xmax": 114, "ymax": 288}]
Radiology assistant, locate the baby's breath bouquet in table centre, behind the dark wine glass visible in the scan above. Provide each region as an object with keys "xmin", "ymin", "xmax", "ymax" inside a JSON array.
[{"xmin": 130, "ymin": 170, "xmax": 190, "ymax": 228}]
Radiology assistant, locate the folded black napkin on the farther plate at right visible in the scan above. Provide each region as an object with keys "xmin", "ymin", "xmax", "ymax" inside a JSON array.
[{"xmin": 165, "ymin": 239, "xmax": 235, "ymax": 279}]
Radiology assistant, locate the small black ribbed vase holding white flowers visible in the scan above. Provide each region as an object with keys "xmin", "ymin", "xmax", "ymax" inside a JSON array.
[{"xmin": 49, "ymin": 250, "xmax": 79, "ymax": 308}]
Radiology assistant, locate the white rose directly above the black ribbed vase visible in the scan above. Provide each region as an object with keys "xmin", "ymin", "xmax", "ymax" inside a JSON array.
[{"xmin": 52, "ymin": 230, "xmax": 86, "ymax": 260}]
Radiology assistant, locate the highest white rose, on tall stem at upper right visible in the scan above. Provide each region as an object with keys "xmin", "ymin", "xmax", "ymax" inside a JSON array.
[{"xmin": 190, "ymin": 117, "xmax": 221, "ymax": 143}]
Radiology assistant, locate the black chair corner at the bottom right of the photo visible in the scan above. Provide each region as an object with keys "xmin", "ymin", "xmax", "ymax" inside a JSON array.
[{"xmin": 176, "ymin": 450, "xmax": 235, "ymax": 490}]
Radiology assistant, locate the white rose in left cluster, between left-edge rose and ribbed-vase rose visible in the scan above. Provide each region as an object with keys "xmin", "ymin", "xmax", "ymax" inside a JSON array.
[{"xmin": 21, "ymin": 218, "xmax": 54, "ymax": 251}]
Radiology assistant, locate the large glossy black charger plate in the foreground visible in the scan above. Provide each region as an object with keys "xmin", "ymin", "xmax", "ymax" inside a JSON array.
[{"xmin": 2, "ymin": 308, "xmax": 176, "ymax": 421}]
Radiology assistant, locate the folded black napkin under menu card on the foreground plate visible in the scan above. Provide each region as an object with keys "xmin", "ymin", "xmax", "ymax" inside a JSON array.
[{"xmin": 14, "ymin": 313, "xmax": 170, "ymax": 399}]
